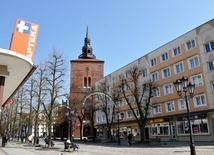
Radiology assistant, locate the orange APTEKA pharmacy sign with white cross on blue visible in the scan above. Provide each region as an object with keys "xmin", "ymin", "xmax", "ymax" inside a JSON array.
[{"xmin": 10, "ymin": 19, "xmax": 39, "ymax": 61}]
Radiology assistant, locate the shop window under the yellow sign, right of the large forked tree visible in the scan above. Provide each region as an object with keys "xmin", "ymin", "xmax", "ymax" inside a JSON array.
[{"xmin": 152, "ymin": 122, "xmax": 170, "ymax": 136}]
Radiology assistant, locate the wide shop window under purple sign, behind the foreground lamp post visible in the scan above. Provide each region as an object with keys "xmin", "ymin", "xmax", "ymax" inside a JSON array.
[{"xmin": 176, "ymin": 118, "xmax": 209, "ymax": 135}]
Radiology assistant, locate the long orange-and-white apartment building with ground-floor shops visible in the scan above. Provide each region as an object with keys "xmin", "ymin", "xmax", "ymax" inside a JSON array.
[{"xmin": 96, "ymin": 19, "xmax": 214, "ymax": 141}]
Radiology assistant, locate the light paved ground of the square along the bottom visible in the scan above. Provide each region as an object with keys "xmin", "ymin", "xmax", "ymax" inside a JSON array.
[{"xmin": 0, "ymin": 141, "xmax": 214, "ymax": 155}]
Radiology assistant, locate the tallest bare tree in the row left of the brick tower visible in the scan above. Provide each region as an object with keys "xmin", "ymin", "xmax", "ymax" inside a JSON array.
[{"xmin": 42, "ymin": 48, "xmax": 66, "ymax": 147}]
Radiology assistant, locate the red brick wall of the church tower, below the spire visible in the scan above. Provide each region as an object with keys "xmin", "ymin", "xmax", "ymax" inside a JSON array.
[{"xmin": 70, "ymin": 59, "xmax": 104, "ymax": 137}]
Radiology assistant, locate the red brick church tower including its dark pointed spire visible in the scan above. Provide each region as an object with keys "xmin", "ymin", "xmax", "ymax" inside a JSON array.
[{"xmin": 70, "ymin": 26, "xmax": 104, "ymax": 137}]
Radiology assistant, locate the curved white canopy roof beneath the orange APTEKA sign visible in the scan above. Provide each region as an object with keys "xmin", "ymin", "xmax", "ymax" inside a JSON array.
[{"xmin": 0, "ymin": 48, "xmax": 37, "ymax": 106}]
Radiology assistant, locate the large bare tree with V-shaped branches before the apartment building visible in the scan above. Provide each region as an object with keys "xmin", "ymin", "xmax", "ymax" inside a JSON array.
[{"xmin": 119, "ymin": 67, "xmax": 152, "ymax": 142}]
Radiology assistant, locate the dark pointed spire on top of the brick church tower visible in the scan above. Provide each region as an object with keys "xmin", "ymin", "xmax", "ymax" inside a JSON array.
[{"xmin": 78, "ymin": 25, "xmax": 96, "ymax": 59}]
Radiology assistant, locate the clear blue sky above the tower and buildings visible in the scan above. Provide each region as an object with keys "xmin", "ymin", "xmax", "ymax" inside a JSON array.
[{"xmin": 0, "ymin": 0, "xmax": 214, "ymax": 76}]
